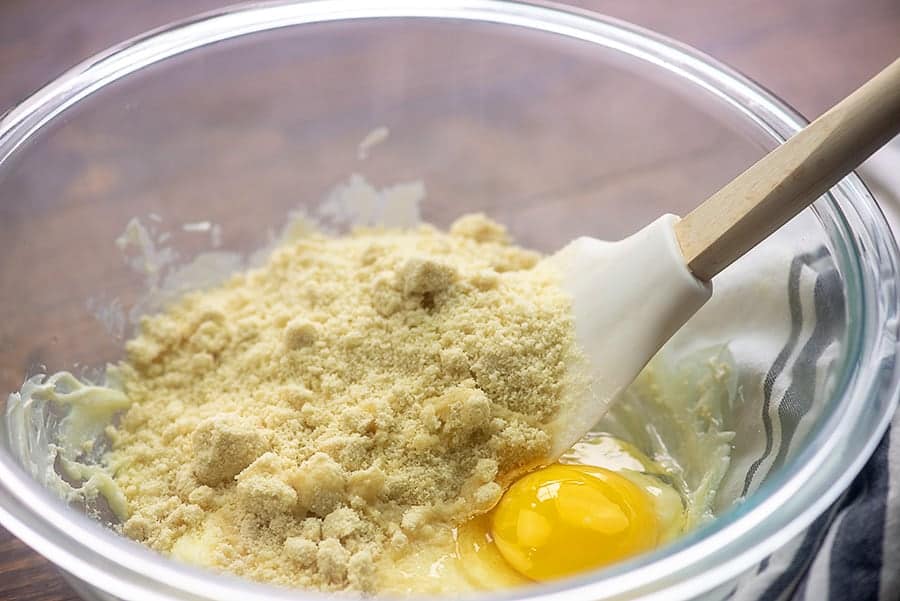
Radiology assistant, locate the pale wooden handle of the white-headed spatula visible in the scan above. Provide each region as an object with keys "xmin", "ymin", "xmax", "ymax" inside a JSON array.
[{"xmin": 675, "ymin": 59, "xmax": 900, "ymax": 280}]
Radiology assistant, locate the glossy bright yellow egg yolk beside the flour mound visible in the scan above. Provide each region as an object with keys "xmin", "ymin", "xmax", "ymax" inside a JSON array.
[{"xmin": 491, "ymin": 465, "xmax": 660, "ymax": 581}]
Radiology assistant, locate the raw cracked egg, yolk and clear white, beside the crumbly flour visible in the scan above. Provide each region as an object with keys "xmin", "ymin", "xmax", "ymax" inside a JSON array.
[{"xmin": 457, "ymin": 436, "xmax": 684, "ymax": 589}]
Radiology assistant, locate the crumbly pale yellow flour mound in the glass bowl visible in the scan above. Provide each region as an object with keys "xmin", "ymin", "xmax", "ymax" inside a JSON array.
[{"xmin": 107, "ymin": 215, "xmax": 574, "ymax": 592}]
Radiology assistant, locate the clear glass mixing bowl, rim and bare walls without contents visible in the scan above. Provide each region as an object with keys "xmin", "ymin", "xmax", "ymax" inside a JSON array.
[{"xmin": 0, "ymin": 0, "xmax": 898, "ymax": 601}]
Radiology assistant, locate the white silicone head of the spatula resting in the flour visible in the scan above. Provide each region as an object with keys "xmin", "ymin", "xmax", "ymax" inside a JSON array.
[{"xmin": 549, "ymin": 215, "xmax": 712, "ymax": 459}]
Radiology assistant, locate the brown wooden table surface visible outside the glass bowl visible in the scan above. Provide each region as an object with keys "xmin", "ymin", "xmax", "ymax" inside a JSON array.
[{"xmin": 0, "ymin": 0, "xmax": 900, "ymax": 601}]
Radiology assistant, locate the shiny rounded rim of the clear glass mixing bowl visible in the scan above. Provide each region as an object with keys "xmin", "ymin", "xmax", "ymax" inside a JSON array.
[{"xmin": 0, "ymin": 0, "xmax": 898, "ymax": 601}]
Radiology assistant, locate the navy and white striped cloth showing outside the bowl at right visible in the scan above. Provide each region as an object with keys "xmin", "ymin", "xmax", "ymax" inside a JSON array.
[{"xmin": 731, "ymin": 138, "xmax": 900, "ymax": 601}]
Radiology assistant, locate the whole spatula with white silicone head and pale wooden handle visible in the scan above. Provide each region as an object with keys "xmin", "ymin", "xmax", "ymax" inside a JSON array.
[{"xmin": 553, "ymin": 59, "xmax": 900, "ymax": 457}]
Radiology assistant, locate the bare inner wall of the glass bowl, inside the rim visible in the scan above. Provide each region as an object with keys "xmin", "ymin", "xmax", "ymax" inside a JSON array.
[{"xmin": 0, "ymin": 5, "xmax": 884, "ymax": 600}]
